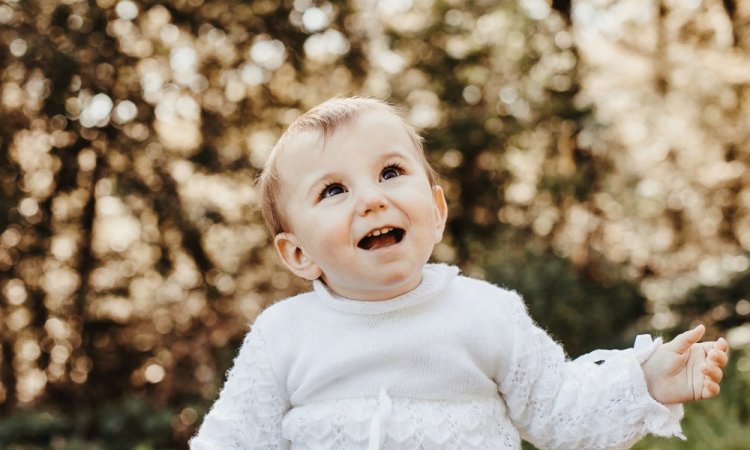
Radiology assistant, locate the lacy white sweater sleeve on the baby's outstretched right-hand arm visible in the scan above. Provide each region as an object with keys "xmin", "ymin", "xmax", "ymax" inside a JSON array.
[{"xmin": 499, "ymin": 295, "xmax": 682, "ymax": 449}]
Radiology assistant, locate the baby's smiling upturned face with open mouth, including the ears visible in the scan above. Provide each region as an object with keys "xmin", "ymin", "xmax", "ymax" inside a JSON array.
[{"xmin": 275, "ymin": 111, "xmax": 447, "ymax": 300}]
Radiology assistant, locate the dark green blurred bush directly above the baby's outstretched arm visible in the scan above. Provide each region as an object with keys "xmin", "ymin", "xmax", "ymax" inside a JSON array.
[{"xmin": 482, "ymin": 232, "xmax": 646, "ymax": 357}]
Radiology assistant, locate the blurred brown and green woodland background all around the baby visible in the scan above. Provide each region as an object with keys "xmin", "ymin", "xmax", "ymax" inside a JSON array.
[{"xmin": 0, "ymin": 0, "xmax": 750, "ymax": 450}]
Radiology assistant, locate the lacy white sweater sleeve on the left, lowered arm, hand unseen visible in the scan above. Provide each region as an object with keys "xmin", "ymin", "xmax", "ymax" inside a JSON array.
[{"xmin": 190, "ymin": 330, "xmax": 289, "ymax": 450}]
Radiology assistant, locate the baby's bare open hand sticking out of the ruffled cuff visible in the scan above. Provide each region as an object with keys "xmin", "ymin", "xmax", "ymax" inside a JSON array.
[{"xmin": 641, "ymin": 325, "xmax": 729, "ymax": 405}]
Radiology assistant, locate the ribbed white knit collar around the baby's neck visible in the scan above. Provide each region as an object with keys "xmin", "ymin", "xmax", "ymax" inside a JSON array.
[{"xmin": 313, "ymin": 264, "xmax": 458, "ymax": 314}]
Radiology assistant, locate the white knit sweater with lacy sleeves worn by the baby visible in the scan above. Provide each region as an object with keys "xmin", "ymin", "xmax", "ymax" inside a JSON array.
[{"xmin": 190, "ymin": 265, "xmax": 682, "ymax": 450}]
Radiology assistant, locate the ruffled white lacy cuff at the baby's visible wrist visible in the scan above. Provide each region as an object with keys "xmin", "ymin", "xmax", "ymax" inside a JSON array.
[{"xmin": 631, "ymin": 334, "xmax": 687, "ymax": 440}]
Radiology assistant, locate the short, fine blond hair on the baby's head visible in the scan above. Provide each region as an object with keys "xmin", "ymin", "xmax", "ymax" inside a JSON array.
[{"xmin": 258, "ymin": 97, "xmax": 437, "ymax": 236}]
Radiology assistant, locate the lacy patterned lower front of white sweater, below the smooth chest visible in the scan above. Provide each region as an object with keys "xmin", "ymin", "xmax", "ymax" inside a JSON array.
[{"xmin": 282, "ymin": 397, "xmax": 520, "ymax": 450}]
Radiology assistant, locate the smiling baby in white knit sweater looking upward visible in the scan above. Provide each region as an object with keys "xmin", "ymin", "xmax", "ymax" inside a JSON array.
[{"xmin": 190, "ymin": 97, "xmax": 728, "ymax": 450}]
